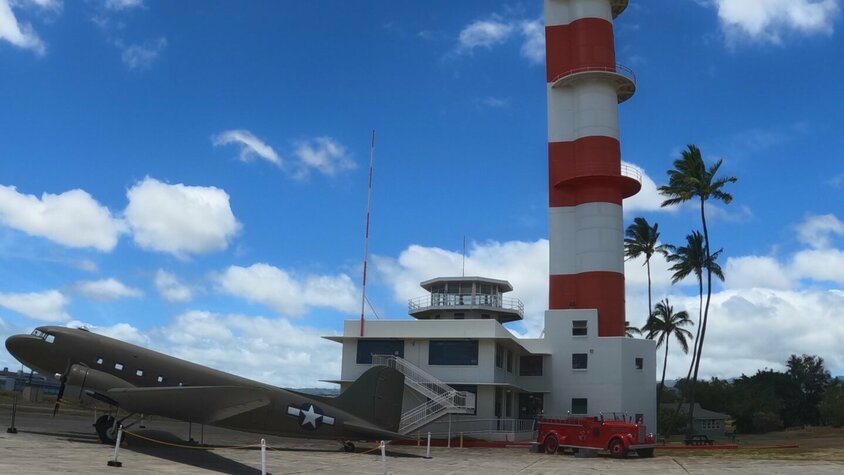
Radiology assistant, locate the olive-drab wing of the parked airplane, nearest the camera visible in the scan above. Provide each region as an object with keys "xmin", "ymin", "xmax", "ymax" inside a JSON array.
[{"xmin": 106, "ymin": 386, "xmax": 270, "ymax": 424}]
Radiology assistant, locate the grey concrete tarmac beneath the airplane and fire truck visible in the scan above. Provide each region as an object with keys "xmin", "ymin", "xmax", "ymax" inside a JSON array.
[{"xmin": 0, "ymin": 408, "xmax": 844, "ymax": 475}]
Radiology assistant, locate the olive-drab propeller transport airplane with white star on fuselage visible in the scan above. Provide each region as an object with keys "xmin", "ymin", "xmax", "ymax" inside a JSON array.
[{"xmin": 6, "ymin": 326, "xmax": 404, "ymax": 451}]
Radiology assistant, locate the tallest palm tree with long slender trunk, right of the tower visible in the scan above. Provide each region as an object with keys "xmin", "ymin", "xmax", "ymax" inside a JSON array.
[{"xmin": 659, "ymin": 145, "xmax": 737, "ymax": 428}]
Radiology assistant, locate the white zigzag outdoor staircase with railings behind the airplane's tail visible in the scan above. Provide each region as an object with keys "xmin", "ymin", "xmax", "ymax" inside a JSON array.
[{"xmin": 372, "ymin": 355, "xmax": 475, "ymax": 434}]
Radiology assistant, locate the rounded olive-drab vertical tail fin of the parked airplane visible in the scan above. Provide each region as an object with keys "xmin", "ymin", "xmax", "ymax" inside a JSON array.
[{"xmin": 333, "ymin": 366, "xmax": 404, "ymax": 432}]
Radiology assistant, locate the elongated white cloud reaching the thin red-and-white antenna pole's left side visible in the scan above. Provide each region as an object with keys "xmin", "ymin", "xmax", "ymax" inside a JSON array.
[{"xmin": 217, "ymin": 263, "xmax": 357, "ymax": 317}]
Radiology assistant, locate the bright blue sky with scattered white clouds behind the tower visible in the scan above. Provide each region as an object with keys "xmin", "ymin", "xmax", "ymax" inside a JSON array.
[{"xmin": 0, "ymin": 0, "xmax": 844, "ymax": 386}]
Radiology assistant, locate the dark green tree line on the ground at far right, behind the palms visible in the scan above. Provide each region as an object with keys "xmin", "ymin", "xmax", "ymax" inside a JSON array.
[{"xmin": 659, "ymin": 355, "xmax": 844, "ymax": 434}]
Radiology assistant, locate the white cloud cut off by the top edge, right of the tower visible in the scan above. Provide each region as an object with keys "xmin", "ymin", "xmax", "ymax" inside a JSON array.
[{"xmin": 714, "ymin": 0, "xmax": 839, "ymax": 44}]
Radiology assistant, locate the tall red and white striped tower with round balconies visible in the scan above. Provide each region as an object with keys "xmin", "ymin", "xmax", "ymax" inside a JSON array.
[{"xmin": 545, "ymin": 0, "xmax": 641, "ymax": 336}]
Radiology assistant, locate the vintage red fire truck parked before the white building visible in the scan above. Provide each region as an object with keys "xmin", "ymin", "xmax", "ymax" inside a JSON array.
[{"xmin": 536, "ymin": 413, "xmax": 656, "ymax": 458}]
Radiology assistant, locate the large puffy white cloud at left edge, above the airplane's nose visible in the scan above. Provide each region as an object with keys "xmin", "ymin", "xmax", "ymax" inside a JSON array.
[{"xmin": 0, "ymin": 185, "xmax": 126, "ymax": 251}]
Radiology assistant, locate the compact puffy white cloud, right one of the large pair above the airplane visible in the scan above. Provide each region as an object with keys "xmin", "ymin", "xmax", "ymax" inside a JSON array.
[{"xmin": 124, "ymin": 177, "xmax": 240, "ymax": 258}]
